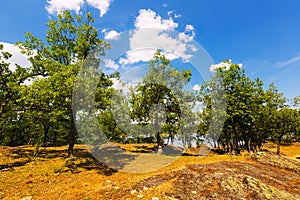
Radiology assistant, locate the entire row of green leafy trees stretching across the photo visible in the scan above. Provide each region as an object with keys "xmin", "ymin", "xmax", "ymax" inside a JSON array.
[{"xmin": 0, "ymin": 11, "xmax": 300, "ymax": 156}]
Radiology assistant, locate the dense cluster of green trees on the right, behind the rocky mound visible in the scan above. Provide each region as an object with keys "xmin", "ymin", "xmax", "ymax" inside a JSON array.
[{"xmin": 198, "ymin": 60, "xmax": 297, "ymax": 153}]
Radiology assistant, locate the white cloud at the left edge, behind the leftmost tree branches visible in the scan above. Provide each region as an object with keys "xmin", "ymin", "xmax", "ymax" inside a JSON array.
[{"xmin": 0, "ymin": 42, "xmax": 31, "ymax": 70}]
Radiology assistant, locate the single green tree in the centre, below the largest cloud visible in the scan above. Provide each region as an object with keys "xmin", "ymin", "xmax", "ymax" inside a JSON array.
[{"xmin": 130, "ymin": 50, "xmax": 191, "ymax": 148}]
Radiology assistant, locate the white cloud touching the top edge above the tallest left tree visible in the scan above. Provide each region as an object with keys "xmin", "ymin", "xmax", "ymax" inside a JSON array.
[{"xmin": 46, "ymin": 0, "xmax": 111, "ymax": 17}]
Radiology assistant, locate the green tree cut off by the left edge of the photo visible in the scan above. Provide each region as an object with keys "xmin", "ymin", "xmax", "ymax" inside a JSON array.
[{"xmin": 0, "ymin": 45, "xmax": 29, "ymax": 146}]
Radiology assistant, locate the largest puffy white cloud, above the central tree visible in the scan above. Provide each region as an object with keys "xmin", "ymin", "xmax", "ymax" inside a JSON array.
[{"xmin": 119, "ymin": 9, "xmax": 196, "ymax": 65}]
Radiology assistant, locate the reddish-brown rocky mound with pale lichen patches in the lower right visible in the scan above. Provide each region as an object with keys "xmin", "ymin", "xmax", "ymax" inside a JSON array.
[{"xmin": 133, "ymin": 155, "xmax": 300, "ymax": 199}]
